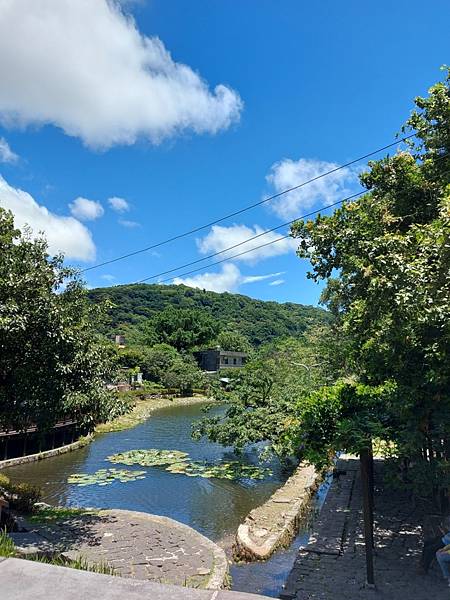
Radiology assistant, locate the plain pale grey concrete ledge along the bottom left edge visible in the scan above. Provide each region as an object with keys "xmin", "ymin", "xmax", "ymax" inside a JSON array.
[{"xmin": 0, "ymin": 558, "xmax": 269, "ymax": 600}]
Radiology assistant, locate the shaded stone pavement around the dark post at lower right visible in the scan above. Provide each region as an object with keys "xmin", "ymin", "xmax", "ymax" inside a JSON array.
[{"xmin": 281, "ymin": 459, "xmax": 450, "ymax": 600}]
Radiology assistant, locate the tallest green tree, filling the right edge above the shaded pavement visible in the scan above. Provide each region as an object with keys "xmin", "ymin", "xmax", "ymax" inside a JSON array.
[{"xmin": 292, "ymin": 68, "xmax": 450, "ymax": 493}]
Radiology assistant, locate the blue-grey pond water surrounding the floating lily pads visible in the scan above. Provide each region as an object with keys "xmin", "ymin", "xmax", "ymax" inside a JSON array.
[{"xmin": 5, "ymin": 404, "xmax": 323, "ymax": 596}]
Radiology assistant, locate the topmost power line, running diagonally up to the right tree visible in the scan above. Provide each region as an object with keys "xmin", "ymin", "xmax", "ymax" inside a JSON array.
[{"xmin": 80, "ymin": 132, "xmax": 417, "ymax": 273}]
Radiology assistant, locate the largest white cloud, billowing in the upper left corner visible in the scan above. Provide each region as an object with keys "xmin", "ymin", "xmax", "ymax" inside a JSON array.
[{"xmin": 0, "ymin": 0, "xmax": 242, "ymax": 148}]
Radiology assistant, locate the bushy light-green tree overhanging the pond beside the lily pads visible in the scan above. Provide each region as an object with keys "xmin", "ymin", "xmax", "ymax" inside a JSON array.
[{"xmin": 194, "ymin": 330, "xmax": 336, "ymax": 457}]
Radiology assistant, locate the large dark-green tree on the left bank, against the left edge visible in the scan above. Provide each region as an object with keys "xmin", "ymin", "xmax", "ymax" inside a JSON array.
[{"xmin": 0, "ymin": 209, "xmax": 123, "ymax": 430}]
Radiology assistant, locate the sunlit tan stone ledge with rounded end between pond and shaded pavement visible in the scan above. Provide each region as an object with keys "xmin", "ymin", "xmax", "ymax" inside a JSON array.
[{"xmin": 233, "ymin": 463, "xmax": 321, "ymax": 560}]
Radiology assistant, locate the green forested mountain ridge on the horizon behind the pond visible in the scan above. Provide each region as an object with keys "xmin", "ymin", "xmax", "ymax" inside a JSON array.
[{"xmin": 89, "ymin": 284, "xmax": 328, "ymax": 346}]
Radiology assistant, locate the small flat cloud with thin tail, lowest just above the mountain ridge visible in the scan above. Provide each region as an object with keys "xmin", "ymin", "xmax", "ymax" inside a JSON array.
[{"xmin": 173, "ymin": 263, "xmax": 281, "ymax": 292}]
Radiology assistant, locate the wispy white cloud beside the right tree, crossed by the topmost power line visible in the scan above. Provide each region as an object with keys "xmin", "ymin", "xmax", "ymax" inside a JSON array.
[{"xmin": 266, "ymin": 158, "xmax": 359, "ymax": 219}]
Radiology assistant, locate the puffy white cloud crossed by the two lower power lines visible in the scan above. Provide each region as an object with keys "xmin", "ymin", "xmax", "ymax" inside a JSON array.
[{"xmin": 197, "ymin": 224, "xmax": 298, "ymax": 264}]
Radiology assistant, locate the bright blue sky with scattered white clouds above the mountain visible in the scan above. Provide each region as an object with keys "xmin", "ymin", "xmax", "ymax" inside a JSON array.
[{"xmin": 0, "ymin": 0, "xmax": 450, "ymax": 304}]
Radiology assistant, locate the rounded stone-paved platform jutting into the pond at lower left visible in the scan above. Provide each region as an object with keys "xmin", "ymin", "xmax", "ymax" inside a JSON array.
[{"xmin": 11, "ymin": 510, "xmax": 228, "ymax": 589}]
